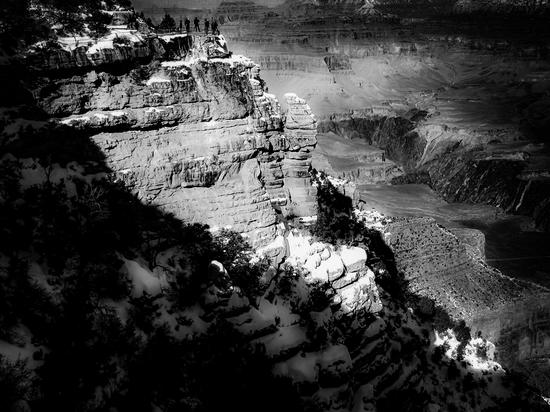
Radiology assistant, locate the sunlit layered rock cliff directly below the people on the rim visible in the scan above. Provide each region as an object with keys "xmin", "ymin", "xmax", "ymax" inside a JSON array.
[{"xmin": 26, "ymin": 34, "xmax": 317, "ymax": 245}]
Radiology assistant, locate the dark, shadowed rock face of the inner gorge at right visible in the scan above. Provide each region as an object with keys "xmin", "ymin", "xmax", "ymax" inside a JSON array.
[{"xmin": 318, "ymin": 111, "xmax": 550, "ymax": 231}]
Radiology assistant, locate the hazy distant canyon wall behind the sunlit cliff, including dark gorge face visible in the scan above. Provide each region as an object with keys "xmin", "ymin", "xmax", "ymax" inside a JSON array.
[{"xmin": 206, "ymin": 1, "xmax": 550, "ymax": 230}]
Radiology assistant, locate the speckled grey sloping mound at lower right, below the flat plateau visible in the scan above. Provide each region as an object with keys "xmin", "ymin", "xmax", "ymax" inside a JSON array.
[{"xmin": 384, "ymin": 214, "xmax": 536, "ymax": 323}]
